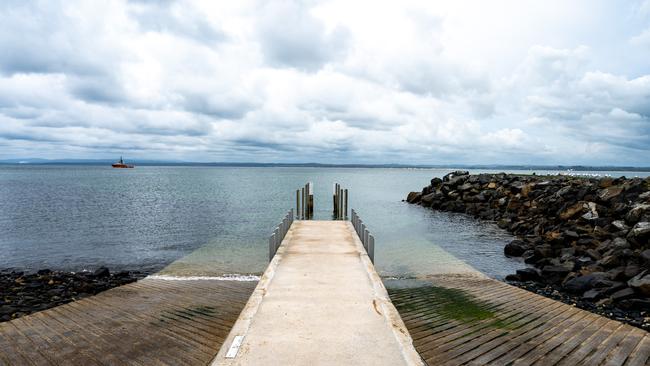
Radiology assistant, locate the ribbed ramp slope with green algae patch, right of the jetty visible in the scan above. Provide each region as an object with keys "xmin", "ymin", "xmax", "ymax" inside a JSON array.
[{"xmin": 389, "ymin": 276, "xmax": 650, "ymax": 366}]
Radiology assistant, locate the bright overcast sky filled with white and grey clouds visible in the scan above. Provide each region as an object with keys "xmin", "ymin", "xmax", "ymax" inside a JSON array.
[{"xmin": 0, "ymin": 0, "xmax": 650, "ymax": 166}]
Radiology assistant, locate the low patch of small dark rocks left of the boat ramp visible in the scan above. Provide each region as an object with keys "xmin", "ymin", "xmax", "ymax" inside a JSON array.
[{"xmin": 0, "ymin": 267, "xmax": 145, "ymax": 321}]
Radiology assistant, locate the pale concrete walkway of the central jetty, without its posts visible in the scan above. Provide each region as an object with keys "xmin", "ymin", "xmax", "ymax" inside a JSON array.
[{"xmin": 213, "ymin": 221, "xmax": 422, "ymax": 366}]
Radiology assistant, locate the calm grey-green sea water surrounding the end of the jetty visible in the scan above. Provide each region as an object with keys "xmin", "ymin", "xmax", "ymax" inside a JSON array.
[{"xmin": 0, "ymin": 166, "xmax": 639, "ymax": 278}]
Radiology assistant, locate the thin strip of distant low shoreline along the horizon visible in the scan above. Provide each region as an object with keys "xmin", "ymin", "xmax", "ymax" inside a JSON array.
[{"xmin": 0, "ymin": 159, "xmax": 650, "ymax": 172}]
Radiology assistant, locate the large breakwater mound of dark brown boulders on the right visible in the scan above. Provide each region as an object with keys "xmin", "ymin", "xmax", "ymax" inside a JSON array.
[{"xmin": 407, "ymin": 171, "xmax": 650, "ymax": 318}]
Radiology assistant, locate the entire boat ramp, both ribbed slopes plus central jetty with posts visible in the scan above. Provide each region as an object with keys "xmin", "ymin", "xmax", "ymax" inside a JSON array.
[{"xmin": 0, "ymin": 197, "xmax": 650, "ymax": 366}]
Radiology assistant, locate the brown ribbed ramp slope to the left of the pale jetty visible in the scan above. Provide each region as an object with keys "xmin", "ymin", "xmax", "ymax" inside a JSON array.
[{"xmin": 0, "ymin": 279, "xmax": 256, "ymax": 366}]
